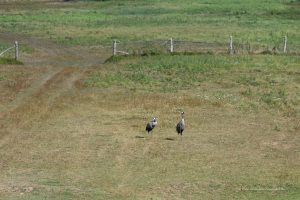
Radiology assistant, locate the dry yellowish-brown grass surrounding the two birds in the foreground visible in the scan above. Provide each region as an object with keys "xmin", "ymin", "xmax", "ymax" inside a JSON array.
[{"xmin": 1, "ymin": 83, "xmax": 299, "ymax": 199}]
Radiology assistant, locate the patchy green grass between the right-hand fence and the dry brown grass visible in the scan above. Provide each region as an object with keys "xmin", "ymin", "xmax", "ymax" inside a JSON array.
[{"xmin": 84, "ymin": 54, "xmax": 300, "ymax": 112}]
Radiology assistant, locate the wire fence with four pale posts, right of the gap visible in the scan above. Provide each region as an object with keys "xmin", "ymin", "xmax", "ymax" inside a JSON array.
[{"xmin": 112, "ymin": 36, "xmax": 300, "ymax": 55}]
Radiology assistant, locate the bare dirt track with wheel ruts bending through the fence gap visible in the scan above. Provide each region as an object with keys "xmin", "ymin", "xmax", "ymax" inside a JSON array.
[{"xmin": 0, "ymin": 33, "xmax": 109, "ymax": 142}]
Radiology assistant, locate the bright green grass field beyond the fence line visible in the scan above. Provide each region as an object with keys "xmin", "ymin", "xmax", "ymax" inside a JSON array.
[{"xmin": 0, "ymin": 0, "xmax": 300, "ymax": 48}]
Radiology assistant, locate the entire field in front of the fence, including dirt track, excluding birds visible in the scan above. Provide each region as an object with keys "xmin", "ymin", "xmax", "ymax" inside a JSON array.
[{"xmin": 0, "ymin": 1, "xmax": 300, "ymax": 200}]
